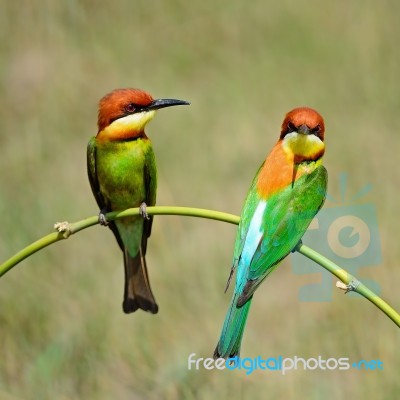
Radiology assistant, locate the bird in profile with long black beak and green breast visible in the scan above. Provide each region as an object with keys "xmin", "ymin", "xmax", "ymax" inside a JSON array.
[{"xmin": 87, "ymin": 89, "xmax": 190, "ymax": 314}]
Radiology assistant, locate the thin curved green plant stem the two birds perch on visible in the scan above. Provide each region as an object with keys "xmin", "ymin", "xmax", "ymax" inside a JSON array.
[{"xmin": 0, "ymin": 207, "xmax": 400, "ymax": 327}]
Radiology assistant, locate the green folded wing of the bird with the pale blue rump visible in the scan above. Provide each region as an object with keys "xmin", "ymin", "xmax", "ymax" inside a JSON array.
[{"xmin": 236, "ymin": 166, "xmax": 327, "ymax": 306}]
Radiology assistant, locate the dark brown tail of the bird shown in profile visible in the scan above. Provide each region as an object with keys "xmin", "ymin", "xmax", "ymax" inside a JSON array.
[{"xmin": 122, "ymin": 248, "xmax": 158, "ymax": 314}]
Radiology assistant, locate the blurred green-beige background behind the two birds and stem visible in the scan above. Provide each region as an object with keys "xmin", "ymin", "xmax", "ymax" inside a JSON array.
[{"xmin": 0, "ymin": 0, "xmax": 400, "ymax": 399}]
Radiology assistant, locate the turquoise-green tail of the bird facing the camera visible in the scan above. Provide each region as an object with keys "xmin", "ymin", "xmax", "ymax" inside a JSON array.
[{"xmin": 214, "ymin": 293, "xmax": 252, "ymax": 359}]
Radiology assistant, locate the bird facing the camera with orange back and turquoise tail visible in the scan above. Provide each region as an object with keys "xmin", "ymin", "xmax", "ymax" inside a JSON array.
[{"xmin": 214, "ymin": 107, "xmax": 328, "ymax": 358}]
